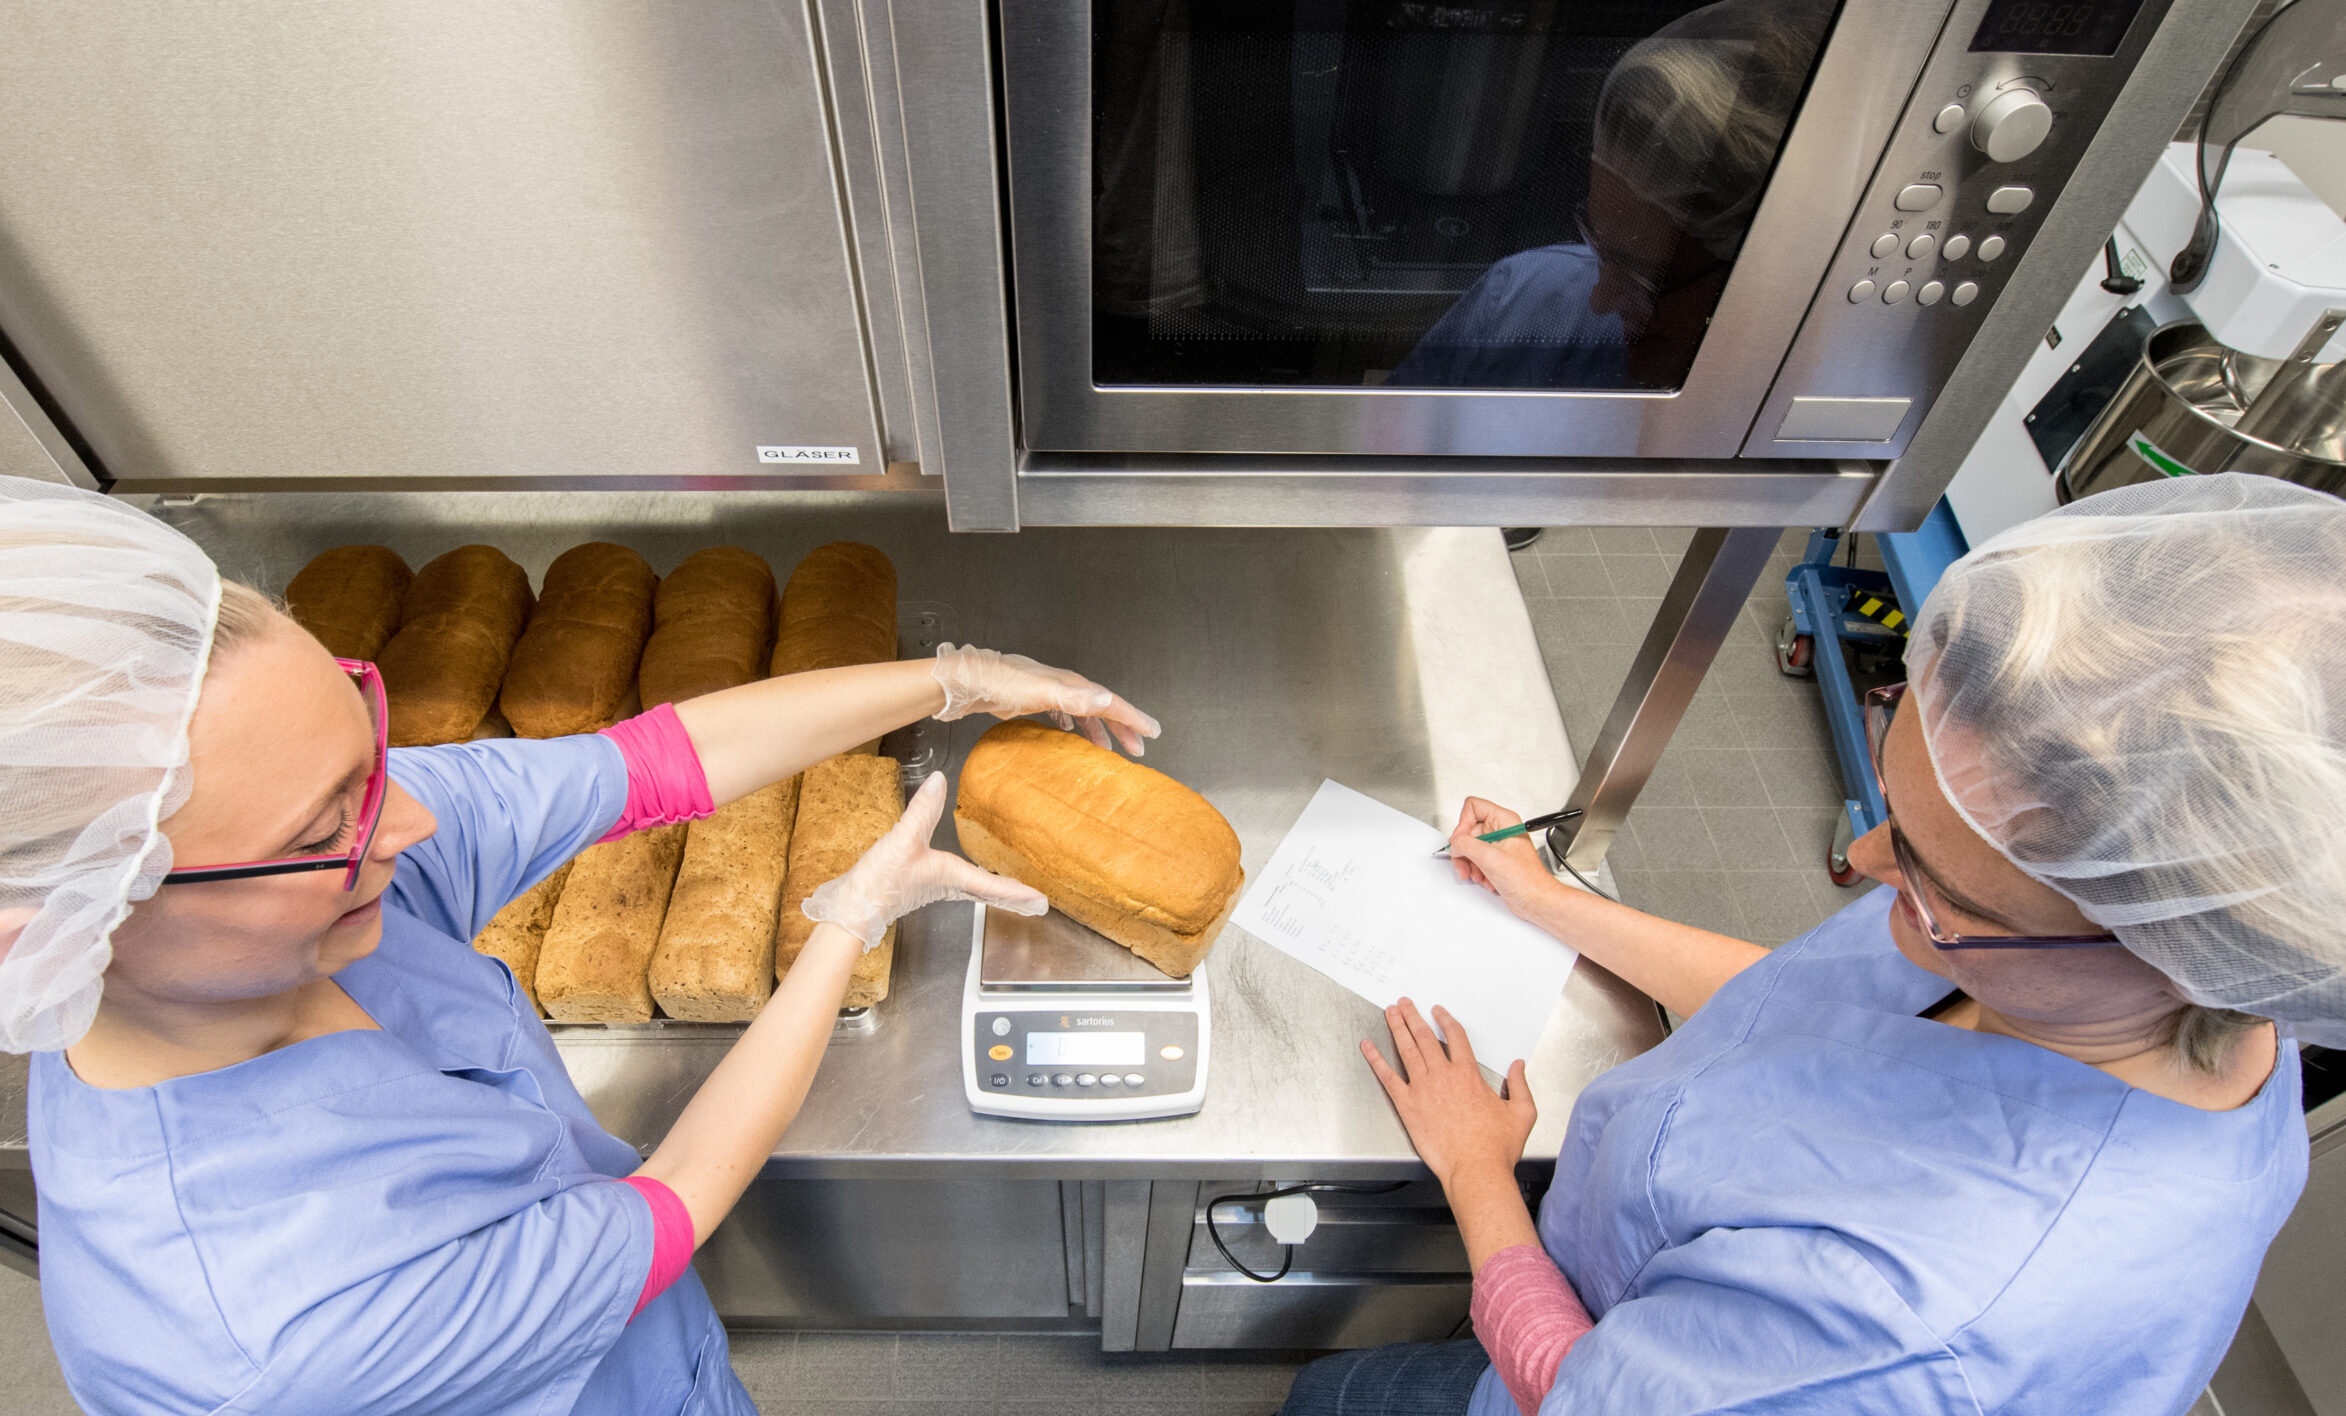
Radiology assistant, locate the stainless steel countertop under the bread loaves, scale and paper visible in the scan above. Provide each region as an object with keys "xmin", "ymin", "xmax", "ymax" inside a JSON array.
[{"xmin": 0, "ymin": 492, "xmax": 1661, "ymax": 1179}]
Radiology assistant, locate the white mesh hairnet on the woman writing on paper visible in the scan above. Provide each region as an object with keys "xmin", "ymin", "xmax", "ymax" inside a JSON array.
[{"xmin": 1907, "ymin": 474, "xmax": 2346, "ymax": 1046}]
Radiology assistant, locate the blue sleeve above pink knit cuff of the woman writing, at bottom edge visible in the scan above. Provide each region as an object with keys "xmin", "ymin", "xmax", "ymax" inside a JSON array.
[{"xmin": 1539, "ymin": 1228, "xmax": 1980, "ymax": 1416}]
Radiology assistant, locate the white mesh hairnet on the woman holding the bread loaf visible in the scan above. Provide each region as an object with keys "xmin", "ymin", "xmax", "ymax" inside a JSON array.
[{"xmin": 0, "ymin": 476, "xmax": 221, "ymax": 1053}]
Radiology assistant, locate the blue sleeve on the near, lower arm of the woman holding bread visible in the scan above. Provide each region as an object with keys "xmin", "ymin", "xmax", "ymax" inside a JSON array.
[{"xmin": 221, "ymin": 1182, "xmax": 652, "ymax": 1416}]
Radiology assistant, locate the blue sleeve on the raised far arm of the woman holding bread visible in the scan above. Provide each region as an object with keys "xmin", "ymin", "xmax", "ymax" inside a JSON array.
[{"xmin": 389, "ymin": 734, "xmax": 626, "ymax": 940}]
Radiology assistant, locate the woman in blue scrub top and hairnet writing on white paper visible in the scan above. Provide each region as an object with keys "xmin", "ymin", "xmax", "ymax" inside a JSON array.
[{"xmin": 1286, "ymin": 474, "xmax": 2346, "ymax": 1416}]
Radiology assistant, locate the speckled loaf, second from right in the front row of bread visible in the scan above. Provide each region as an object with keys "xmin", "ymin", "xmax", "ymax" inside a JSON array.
[{"xmin": 650, "ymin": 776, "xmax": 798, "ymax": 1022}]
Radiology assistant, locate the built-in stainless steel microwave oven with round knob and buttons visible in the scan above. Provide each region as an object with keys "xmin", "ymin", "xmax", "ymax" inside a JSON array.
[{"xmin": 999, "ymin": 0, "xmax": 2170, "ymax": 473}]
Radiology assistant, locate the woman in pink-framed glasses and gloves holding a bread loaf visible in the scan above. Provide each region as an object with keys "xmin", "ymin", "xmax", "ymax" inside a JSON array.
[{"xmin": 0, "ymin": 478, "xmax": 1157, "ymax": 1416}]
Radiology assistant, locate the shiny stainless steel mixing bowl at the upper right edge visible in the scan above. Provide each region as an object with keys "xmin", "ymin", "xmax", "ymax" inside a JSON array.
[{"xmin": 2057, "ymin": 309, "xmax": 2346, "ymax": 502}]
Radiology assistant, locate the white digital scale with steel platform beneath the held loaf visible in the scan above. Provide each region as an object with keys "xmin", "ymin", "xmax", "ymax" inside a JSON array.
[{"xmin": 962, "ymin": 905, "xmax": 1211, "ymax": 1121}]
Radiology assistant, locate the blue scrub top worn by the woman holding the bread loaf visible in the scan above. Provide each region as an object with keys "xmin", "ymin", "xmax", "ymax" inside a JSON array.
[{"xmin": 30, "ymin": 736, "xmax": 755, "ymax": 1416}]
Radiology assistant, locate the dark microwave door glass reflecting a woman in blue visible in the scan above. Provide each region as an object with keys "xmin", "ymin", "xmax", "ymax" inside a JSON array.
[{"xmin": 1091, "ymin": 0, "xmax": 1835, "ymax": 389}]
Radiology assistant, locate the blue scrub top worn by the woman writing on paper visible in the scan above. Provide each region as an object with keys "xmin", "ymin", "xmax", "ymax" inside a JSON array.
[{"xmin": 1471, "ymin": 889, "xmax": 2306, "ymax": 1416}]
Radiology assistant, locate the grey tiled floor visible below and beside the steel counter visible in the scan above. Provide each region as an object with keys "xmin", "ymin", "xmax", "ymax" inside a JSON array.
[{"xmin": 0, "ymin": 527, "xmax": 1856, "ymax": 1416}]
